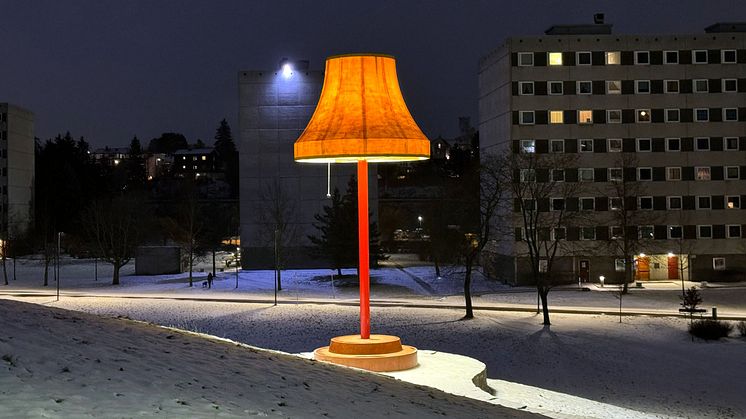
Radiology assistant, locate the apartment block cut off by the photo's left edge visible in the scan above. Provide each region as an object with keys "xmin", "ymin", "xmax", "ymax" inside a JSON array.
[{"xmin": 0, "ymin": 103, "xmax": 34, "ymax": 236}]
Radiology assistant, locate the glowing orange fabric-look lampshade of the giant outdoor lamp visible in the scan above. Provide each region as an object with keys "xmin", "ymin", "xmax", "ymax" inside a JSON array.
[{"xmin": 295, "ymin": 54, "xmax": 430, "ymax": 163}]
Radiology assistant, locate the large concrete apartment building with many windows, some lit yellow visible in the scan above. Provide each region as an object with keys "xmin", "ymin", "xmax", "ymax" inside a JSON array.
[{"xmin": 479, "ymin": 22, "xmax": 746, "ymax": 283}]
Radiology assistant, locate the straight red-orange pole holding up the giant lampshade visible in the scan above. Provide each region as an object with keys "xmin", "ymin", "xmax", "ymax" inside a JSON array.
[{"xmin": 357, "ymin": 160, "xmax": 370, "ymax": 339}]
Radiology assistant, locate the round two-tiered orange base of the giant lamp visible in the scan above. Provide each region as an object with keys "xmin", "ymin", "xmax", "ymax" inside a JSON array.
[{"xmin": 313, "ymin": 335, "xmax": 417, "ymax": 372}]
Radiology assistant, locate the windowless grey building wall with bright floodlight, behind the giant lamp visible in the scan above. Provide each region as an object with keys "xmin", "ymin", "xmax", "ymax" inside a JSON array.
[{"xmin": 238, "ymin": 60, "xmax": 370, "ymax": 269}]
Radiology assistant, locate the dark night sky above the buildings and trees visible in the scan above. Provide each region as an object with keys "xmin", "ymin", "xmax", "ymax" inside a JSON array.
[{"xmin": 0, "ymin": 0, "xmax": 746, "ymax": 146}]
